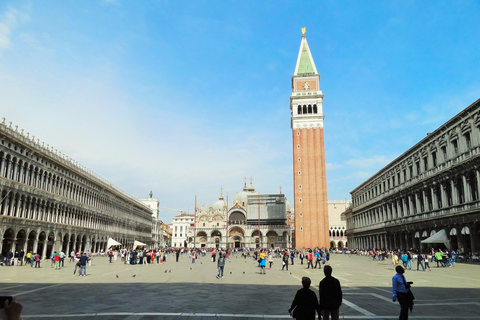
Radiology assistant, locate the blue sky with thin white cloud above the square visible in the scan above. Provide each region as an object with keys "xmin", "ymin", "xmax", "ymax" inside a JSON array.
[{"xmin": 0, "ymin": 0, "xmax": 480, "ymax": 222}]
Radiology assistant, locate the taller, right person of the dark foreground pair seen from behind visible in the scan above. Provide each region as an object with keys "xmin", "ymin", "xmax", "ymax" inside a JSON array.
[{"xmin": 319, "ymin": 266, "xmax": 342, "ymax": 320}]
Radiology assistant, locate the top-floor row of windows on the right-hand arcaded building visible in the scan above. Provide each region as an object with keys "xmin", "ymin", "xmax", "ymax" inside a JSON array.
[{"xmin": 352, "ymin": 126, "xmax": 480, "ymax": 206}]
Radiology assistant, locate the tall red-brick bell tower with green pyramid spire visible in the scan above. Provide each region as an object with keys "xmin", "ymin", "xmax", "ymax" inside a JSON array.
[{"xmin": 290, "ymin": 28, "xmax": 330, "ymax": 248}]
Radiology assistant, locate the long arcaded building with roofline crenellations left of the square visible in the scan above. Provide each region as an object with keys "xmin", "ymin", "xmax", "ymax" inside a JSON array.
[{"xmin": 0, "ymin": 118, "xmax": 163, "ymax": 257}]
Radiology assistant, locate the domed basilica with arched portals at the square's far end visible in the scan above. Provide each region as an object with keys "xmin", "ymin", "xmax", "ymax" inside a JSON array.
[{"xmin": 173, "ymin": 182, "xmax": 292, "ymax": 248}]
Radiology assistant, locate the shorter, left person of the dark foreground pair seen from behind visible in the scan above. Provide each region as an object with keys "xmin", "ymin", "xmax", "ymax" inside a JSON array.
[{"xmin": 288, "ymin": 277, "xmax": 320, "ymax": 320}]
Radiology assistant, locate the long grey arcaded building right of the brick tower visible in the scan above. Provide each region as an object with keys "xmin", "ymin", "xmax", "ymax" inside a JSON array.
[{"xmin": 344, "ymin": 99, "xmax": 480, "ymax": 253}]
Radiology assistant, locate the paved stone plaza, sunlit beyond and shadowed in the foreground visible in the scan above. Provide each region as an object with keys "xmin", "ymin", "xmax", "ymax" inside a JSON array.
[{"xmin": 0, "ymin": 254, "xmax": 480, "ymax": 320}]
